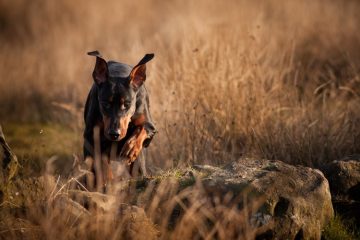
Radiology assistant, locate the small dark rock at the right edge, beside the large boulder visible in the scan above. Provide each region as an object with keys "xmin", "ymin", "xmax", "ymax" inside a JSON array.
[{"xmin": 323, "ymin": 159, "xmax": 360, "ymax": 201}]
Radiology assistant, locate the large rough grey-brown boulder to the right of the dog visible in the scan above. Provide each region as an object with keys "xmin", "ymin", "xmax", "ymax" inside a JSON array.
[{"xmin": 194, "ymin": 159, "xmax": 334, "ymax": 239}]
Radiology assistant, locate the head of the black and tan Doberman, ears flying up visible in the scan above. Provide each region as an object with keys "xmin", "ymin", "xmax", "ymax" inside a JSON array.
[{"xmin": 88, "ymin": 51, "xmax": 154, "ymax": 141}]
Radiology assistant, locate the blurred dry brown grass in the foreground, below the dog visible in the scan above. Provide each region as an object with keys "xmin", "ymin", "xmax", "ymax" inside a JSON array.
[{"xmin": 0, "ymin": 166, "xmax": 261, "ymax": 239}]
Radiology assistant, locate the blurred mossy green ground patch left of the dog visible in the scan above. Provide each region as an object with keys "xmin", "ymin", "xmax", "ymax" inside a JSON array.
[{"xmin": 2, "ymin": 123, "xmax": 82, "ymax": 175}]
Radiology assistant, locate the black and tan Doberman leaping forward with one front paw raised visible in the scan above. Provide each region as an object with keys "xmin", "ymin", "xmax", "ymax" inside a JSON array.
[{"xmin": 83, "ymin": 51, "xmax": 156, "ymax": 188}]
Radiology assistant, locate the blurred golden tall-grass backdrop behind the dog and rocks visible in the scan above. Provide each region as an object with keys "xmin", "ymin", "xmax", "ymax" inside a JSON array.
[{"xmin": 0, "ymin": 0, "xmax": 360, "ymax": 172}]
